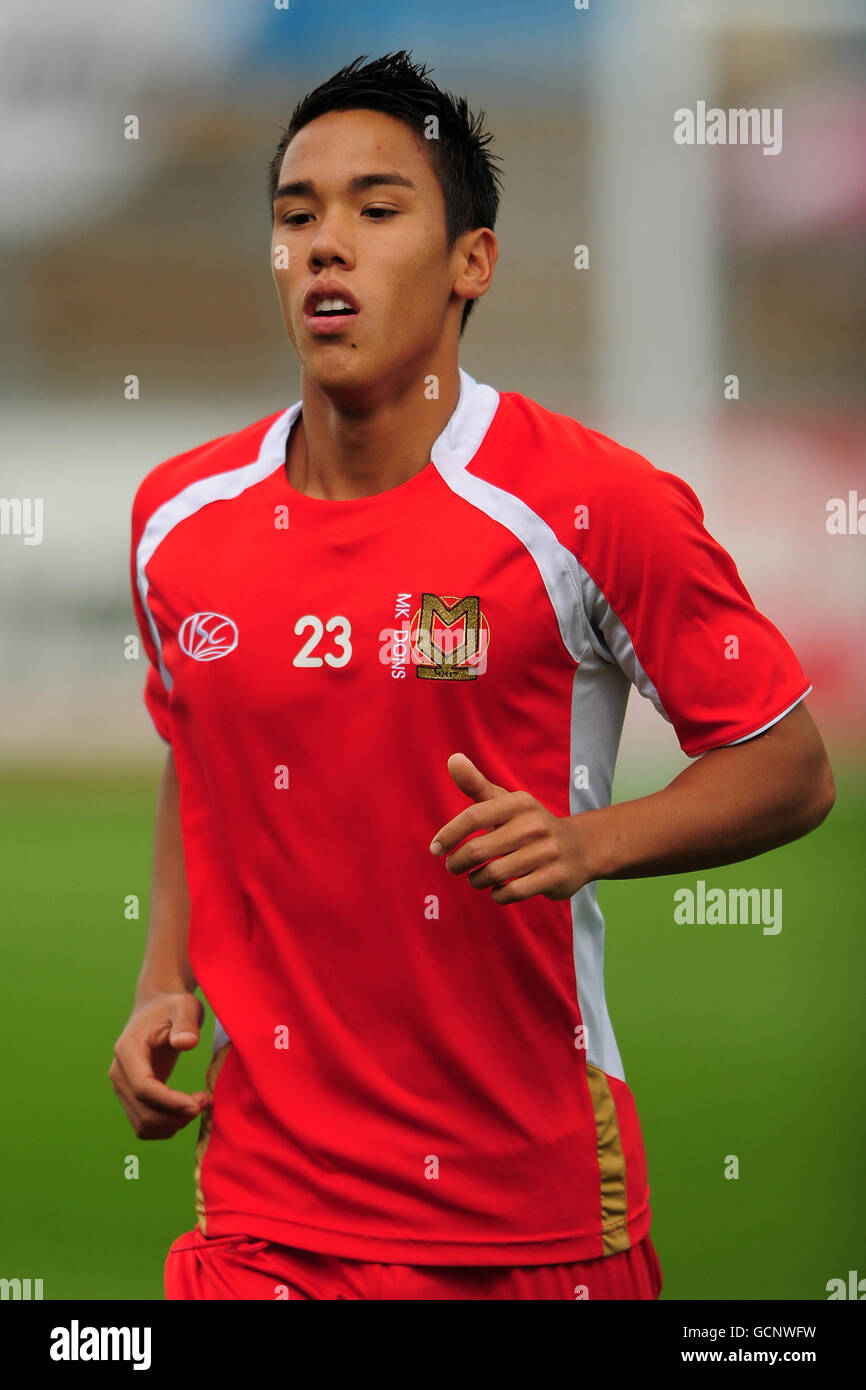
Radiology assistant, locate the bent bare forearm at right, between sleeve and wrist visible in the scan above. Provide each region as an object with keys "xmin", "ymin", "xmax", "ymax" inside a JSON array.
[{"xmin": 571, "ymin": 702, "xmax": 835, "ymax": 881}]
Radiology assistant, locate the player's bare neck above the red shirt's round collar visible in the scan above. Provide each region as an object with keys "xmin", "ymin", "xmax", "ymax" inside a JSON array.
[{"xmin": 286, "ymin": 363, "xmax": 460, "ymax": 500}]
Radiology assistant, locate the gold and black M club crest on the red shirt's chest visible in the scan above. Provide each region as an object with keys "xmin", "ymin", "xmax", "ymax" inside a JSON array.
[{"xmin": 409, "ymin": 594, "xmax": 491, "ymax": 681}]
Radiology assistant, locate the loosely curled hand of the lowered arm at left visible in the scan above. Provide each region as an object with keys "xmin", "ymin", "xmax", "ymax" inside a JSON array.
[{"xmin": 108, "ymin": 992, "xmax": 213, "ymax": 1138}]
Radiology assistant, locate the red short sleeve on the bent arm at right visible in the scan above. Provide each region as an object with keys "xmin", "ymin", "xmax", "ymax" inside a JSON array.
[{"xmin": 578, "ymin": 455, "xmax": 812, "ymax": 758}]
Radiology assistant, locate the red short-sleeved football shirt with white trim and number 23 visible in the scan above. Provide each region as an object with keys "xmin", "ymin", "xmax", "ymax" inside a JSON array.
[{"xmin": 132, "ymin": 371, "xmax": 810, "ymax": 1265}]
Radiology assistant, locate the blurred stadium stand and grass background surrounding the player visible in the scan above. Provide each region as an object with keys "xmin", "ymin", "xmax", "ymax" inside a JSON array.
[{"xmin": 0, "ymin": 0, "xmax": 866, "ymax": 1300}]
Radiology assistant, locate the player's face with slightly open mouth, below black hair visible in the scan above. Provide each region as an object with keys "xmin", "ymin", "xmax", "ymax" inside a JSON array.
[{"xmin": 271, "ymin": 110, "xmax": 464, "ymax": 400}]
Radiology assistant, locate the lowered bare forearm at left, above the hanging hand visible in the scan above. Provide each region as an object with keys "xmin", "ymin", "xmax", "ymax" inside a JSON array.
[{"xmin": 135, "ymin": 751, "xmax": 196, "ymax": 1005}]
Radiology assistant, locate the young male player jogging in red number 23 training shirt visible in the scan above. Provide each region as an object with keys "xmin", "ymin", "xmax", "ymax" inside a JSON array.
[{"xmin": 110, "ymin": 54, "xmax": 834, "ymax": 1300}]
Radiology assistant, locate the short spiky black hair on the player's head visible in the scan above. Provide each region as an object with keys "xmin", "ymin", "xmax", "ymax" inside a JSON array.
[{"xmin": 268, "ymin": 49, "xmax": 502, "ymax": 332}]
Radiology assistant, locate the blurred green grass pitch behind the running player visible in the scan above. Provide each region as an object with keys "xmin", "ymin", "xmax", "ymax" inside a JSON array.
[{"xmin": 0, "ymin": 770, "xmax": 866, "ymax": 1300}]
